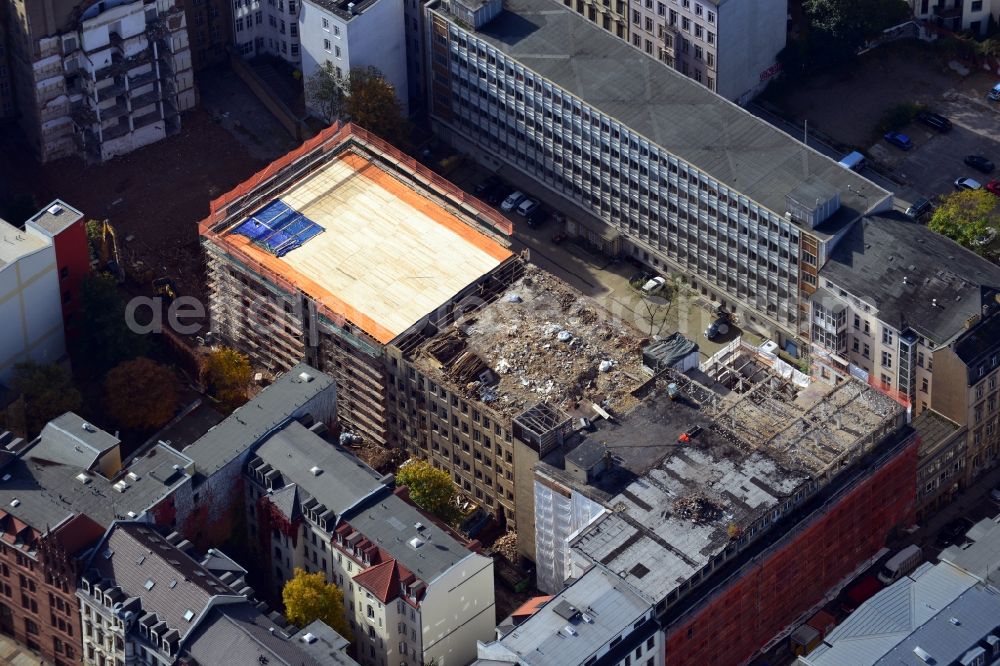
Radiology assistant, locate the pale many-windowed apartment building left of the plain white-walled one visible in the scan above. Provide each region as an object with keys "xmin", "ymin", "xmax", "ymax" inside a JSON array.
[{"xmin": 232, "ymin": 0, "xmax": 302, "ymax": 66}]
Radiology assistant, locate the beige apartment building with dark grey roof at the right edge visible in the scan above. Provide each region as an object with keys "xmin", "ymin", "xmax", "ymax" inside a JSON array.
[{"xmin": 812, "ymin": 213, "xmax": 1000, "ymax": 478}]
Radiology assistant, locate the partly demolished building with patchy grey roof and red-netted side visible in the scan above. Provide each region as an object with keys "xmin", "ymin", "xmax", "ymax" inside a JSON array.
[{"xmin": 479, "ymin": 341, "xmax": 917, "ymax": 666}]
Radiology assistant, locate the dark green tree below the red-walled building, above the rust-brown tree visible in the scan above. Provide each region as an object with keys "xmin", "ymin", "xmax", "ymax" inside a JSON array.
[{"xmin": 74, "ymin": 274, "xmax": 149, "ymax": 372}]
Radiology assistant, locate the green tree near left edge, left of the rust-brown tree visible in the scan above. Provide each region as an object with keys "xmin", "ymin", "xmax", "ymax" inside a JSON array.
[{"xmin": 10, "ymin": 361, "xmax": 83, "ymax": 437}]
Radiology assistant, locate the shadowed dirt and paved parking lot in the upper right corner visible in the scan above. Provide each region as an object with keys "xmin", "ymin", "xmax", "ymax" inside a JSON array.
[{"xmin": 761, "ymin": 42, "xmax": 1000, "ymax": 208}]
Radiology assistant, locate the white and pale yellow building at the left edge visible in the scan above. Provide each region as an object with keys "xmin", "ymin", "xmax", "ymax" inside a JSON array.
[{"xmin": 0, "ymin": 219, "xmax": 66, "ymax": 382}]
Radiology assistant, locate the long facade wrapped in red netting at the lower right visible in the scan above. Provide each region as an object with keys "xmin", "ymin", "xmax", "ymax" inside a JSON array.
[{"xmin": 664, "ymin": 431, "xmax": 919, "ymax": 666}]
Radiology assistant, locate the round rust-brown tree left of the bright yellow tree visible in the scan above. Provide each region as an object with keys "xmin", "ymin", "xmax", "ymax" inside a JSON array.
[{"xmin": 104, "ymin": 358, "xmax": 178, "ymax": 430}]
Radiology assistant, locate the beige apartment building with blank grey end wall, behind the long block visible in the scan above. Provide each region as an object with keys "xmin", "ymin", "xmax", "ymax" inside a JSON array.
[{"xmin": 576, "ymin": 0, "xmax": 788, "ymax": 101}]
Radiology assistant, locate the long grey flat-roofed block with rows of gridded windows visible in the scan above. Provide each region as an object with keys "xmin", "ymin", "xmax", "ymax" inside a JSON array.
[{"xmin": 427, "ymin": 0, "xmax": 892, "ymax": 355}]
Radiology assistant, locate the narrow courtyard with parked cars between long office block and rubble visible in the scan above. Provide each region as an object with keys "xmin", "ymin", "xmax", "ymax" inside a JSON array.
[{"xmin": 448, "ymin": 158, "xmax": 763, "ymax": 359}]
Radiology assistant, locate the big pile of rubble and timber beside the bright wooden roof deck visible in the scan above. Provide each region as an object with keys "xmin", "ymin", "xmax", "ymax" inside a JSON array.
[{"xmin": 424, "ymin": 266, "xmax": 645, "ymax": 415}]
